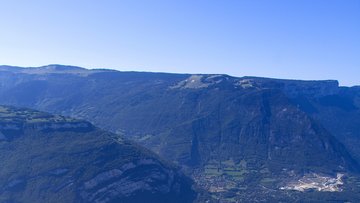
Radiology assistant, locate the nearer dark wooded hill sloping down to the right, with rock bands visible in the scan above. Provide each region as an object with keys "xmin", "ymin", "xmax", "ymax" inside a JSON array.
[{"xmin": 0, "ymin": 106, "xmax": 195, "ymax": 203}]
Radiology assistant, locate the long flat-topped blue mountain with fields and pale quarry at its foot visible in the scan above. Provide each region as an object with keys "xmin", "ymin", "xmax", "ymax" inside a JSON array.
[{"xmin": 0, "ymin": 65, "xmax": 360, "ymax": 201}]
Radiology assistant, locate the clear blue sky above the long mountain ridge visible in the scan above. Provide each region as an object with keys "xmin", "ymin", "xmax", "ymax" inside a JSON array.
[{"xmin": 0, "ymin": 0, "xmax": 360, "ymax": 85}]
